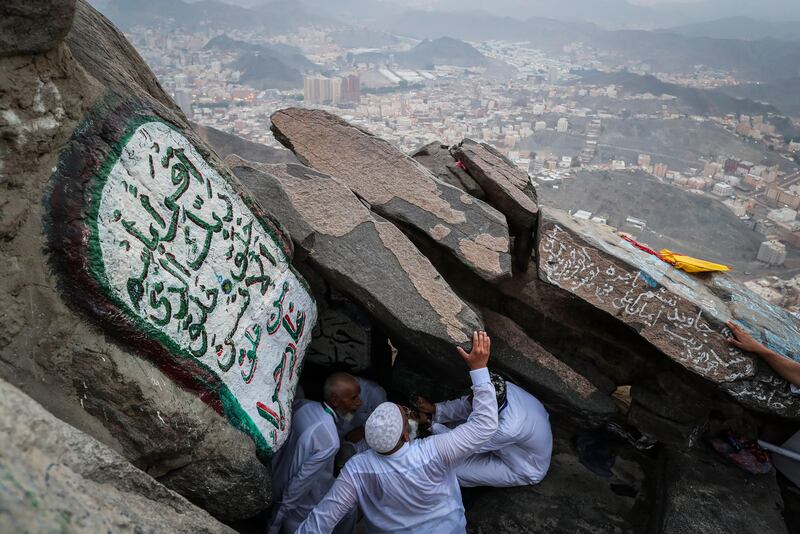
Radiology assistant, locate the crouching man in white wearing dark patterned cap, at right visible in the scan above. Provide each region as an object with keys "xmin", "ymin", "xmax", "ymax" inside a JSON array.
[{"xmin": 416, "ymin": 373, "xmax": 553, "ymax": 487}]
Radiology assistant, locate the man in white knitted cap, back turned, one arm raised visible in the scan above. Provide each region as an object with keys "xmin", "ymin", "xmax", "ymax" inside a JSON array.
[{"xmin": 297, "ymin": 332, "xmax": 497, "ymax": 534}]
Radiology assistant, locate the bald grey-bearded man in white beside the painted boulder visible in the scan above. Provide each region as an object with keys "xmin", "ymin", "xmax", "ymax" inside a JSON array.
[{"xmin": 268, "ymin": 373, "xmax": 360, "ymax": 534}]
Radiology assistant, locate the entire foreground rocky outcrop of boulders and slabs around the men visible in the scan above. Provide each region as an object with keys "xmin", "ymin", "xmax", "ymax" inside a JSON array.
[{"xmin": 0, "ymin": 0, "xmax": 800, "ymax": 534}]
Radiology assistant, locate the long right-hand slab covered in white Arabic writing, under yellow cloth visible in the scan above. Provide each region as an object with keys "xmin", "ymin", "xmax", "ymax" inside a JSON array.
[{"xmin": 538, "ymin": 208, "xmax": 800, "ymax": 417}]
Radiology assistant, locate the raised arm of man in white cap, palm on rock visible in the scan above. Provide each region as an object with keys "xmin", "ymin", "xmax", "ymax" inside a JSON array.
[{"xmin": 427, "ymin": 332, "xmax": 497, "ymax": 467}]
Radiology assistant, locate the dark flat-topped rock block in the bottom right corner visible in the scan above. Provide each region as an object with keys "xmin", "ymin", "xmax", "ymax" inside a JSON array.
[{"xmin": 653, "ymin": 449, "xmax": 787, "ymax": 534}]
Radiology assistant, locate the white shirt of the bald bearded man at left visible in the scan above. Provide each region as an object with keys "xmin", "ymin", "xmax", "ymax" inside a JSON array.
[{"xmin": 269, "ymin": 400, "xmax": 339, "ymax": 533}]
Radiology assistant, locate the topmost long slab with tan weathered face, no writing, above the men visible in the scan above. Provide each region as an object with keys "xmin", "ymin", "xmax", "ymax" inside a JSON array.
[{"xmin": 272, "ymin": 108, "xmax": 511, "ymax": 282}]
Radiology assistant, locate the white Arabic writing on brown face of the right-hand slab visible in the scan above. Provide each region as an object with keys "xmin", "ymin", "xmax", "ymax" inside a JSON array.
[{"xmin": 540, "ymin": 224, "xmax": 755, "ymax": 382}]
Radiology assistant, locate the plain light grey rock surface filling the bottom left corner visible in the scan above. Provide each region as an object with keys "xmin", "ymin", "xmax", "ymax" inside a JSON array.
[{"xmin": 0, "ymin": 380, "xmax": 234, "ymax": 533}]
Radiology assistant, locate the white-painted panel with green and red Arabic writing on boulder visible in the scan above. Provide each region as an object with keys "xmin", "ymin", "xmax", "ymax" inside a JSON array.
[{"xmin": 90, "ymin": 121, "xmax": 316, "ymax": 449}]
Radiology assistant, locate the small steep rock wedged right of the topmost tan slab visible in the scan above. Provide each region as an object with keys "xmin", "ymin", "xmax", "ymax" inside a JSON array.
[{"xmin": 453, "ymin": 139, "xmax": 539, "ymax": 271}]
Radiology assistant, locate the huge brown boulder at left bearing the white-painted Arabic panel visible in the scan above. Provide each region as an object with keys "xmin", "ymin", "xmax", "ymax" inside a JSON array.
[{"xmin": 0, "ymin": 0, "xmax": 316, "ymax": 520}]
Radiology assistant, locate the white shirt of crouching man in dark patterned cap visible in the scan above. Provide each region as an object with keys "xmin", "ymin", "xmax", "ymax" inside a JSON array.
[{"xmin": 434, "ymin": 382, "xmax": 553, "ymax": 485}]
